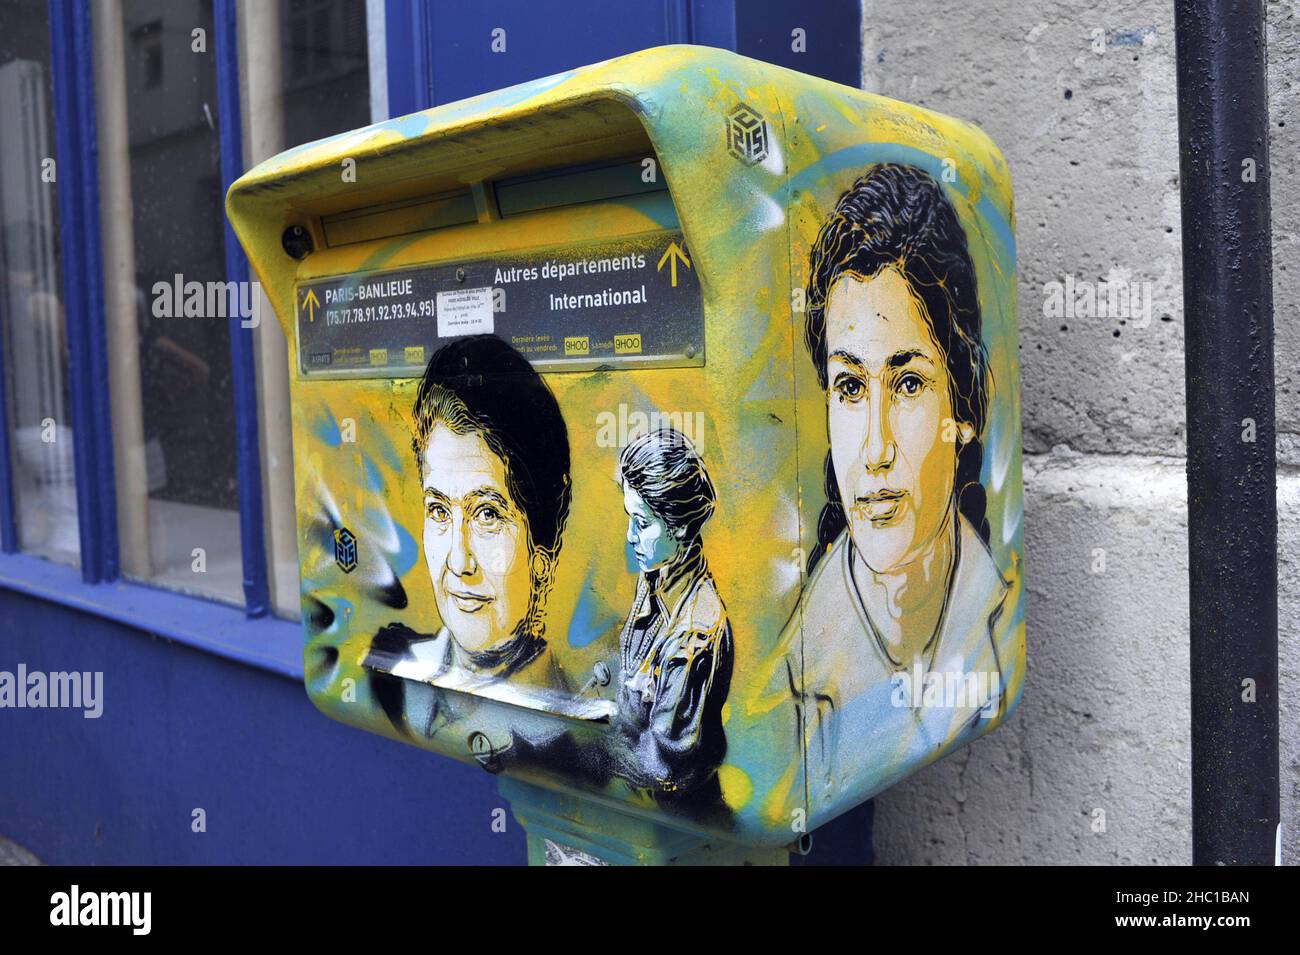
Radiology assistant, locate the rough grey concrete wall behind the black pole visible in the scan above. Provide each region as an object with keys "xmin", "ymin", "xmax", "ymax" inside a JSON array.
[{"xmin": 862, "ymin": 0, "xmax": 1300, "ymax": 864}]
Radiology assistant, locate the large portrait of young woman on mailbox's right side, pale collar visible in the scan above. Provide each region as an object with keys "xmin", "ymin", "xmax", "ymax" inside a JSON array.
[{"xmin": 790, "ymin": 164, "xmax": 1008, "ymax": 789}]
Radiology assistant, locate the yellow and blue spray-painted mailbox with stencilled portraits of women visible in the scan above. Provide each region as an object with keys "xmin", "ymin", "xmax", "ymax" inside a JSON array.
[{"xmin": 228, "ymin": 47, "xmax": 1024, "ymax": 861}]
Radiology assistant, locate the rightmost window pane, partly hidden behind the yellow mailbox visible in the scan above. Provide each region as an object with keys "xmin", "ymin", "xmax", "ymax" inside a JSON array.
[{"xmin": 239, "ymin": 0, "xmax": 371, "ymax": 617}]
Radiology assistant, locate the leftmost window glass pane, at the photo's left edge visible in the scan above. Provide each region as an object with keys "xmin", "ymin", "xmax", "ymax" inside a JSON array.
[{"xmin": 0, "ymin": 0, "xmax": 79, "ymax": 564}]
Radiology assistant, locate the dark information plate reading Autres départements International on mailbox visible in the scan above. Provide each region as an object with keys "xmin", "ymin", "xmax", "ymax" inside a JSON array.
[{"xmin": 296, "ymin": 233, "xmax": 705, "ymax": 378}]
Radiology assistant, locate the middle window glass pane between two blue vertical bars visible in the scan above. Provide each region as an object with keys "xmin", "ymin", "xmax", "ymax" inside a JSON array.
[{"xmin": 94, "ymin": 0, "xmax": 243, "ymax": 603}]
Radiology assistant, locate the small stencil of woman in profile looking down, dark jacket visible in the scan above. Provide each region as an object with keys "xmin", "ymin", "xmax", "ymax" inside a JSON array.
[{"xmin": 618, "ymin": 429, "xmax": 732, "ymax": 806}]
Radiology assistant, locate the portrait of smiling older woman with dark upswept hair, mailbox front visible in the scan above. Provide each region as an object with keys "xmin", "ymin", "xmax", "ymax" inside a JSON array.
[{"xmin": 367, "ymin": 335, "xmax": 571, "ymax": 738}]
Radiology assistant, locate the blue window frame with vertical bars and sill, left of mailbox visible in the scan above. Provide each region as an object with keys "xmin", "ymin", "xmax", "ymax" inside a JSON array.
[{"xmin": 0, "ymin": 0, "xmax": 302, "ymax": 680}]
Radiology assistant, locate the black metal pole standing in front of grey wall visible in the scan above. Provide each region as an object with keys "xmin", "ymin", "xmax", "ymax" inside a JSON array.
[{"xmin": 1175, "ymin": 0, "xmax": 1278, "ymax": 865}]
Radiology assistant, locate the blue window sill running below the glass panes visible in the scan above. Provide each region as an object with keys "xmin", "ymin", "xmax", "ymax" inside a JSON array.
[{"xmin": 0, "ymin": 554, "xmax": 303, "ymax": 681}]
